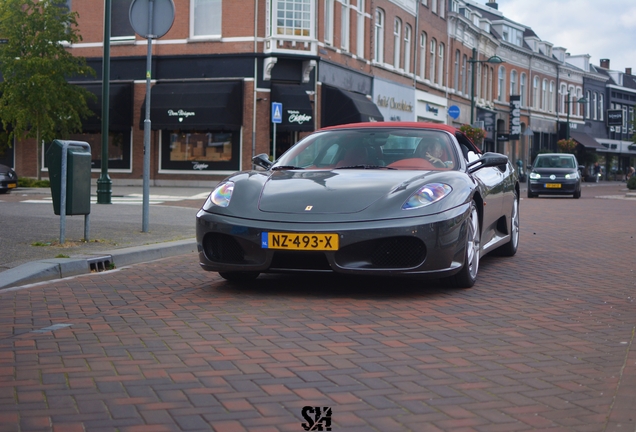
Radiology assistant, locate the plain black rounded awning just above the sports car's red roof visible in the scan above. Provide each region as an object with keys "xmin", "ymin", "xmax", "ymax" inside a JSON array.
[{"xmin": 321, "ymin": 85, "xmax": 384, "ymax": 127}]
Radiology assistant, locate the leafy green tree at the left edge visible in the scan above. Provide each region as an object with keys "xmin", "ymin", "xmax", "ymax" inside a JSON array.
[{"xmin": 0, "ymin": 0, "xmax": 95, "ymax": 179}]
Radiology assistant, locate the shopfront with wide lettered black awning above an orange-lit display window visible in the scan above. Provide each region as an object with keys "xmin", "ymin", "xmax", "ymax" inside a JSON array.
[{"xmin": 139, "ymin": 80, "xmax": 243, "ymax": 174}]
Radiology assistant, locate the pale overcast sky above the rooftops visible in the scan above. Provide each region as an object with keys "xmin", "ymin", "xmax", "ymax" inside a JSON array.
[{"xmin": 477, "ymin": 0, "xmax": 636, "ymax": 74}]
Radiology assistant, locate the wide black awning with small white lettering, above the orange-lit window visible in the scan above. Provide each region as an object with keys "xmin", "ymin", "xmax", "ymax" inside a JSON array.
[{"xmin": 140, "ymin": 81, "xmax": 243, "ymax": 130}]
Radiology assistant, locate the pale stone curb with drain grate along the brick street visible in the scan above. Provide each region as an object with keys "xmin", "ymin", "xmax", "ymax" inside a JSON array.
[{"xmin": 0, "ymin": 239, "xmax": 197, "ymax": 289}]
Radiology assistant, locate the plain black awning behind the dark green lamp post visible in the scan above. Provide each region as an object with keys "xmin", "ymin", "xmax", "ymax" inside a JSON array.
[{"xmin": 80, "ymin": 82, "xmax": 133, "ymax": 132}]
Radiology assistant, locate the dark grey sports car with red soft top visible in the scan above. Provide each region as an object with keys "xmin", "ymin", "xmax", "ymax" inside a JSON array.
[{"xmin": 196, "ymin": 122, "xmax": 519, "ymax": 287}]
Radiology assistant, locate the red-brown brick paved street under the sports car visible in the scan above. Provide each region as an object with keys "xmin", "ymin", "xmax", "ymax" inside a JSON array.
[{"xmin": 0, "ymin": 187, "xmax": 636, "ymax": 432}]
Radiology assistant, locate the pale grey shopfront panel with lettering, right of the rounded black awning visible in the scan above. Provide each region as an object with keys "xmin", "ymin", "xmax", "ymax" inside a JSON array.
[{"xmin": 373, "ymin": 78, "xmax": 415, "ymax": 121}]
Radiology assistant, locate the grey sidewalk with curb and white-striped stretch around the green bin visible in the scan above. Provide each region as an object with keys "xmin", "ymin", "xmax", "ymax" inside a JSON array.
[{"xmin": 0, "ymin": 186, "xmax": 210, "ymax": 289}]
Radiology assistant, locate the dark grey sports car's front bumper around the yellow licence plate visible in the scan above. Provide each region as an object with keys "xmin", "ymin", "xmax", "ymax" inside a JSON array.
[{"xmin": 196, "ymin": 204, "xmax": 470, "ymax": 277}]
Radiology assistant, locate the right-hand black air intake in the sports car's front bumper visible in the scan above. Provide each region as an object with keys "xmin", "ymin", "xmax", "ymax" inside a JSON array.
[{"xmin": 336, "ymin": 237, "xmax": 426, "ymax": 269}]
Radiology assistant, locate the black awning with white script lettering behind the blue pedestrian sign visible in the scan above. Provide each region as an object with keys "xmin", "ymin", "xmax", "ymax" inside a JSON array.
[{"xmin": 271, "ymin": 83, "xmax": 314, "ymax": 132}]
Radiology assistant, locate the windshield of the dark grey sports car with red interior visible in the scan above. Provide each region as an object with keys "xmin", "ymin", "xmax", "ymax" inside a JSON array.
[{"xmin": 273, "ymin": 128, "xmax": 459, "ymax": 170}]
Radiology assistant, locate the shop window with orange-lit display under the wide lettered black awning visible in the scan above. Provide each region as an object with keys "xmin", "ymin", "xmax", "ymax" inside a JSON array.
[{"xmin": 161, "ymin": 131, "xmax": 239, "ymax": 171}]
